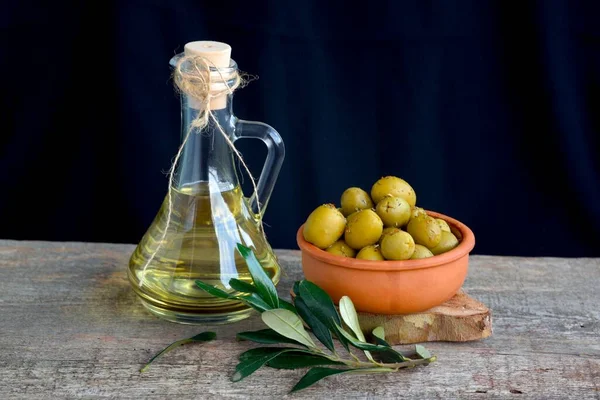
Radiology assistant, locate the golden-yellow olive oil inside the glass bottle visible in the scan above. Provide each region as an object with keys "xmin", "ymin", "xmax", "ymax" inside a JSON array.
[{"xmin": 129, "ymin": 182, "xmax": 280, "ymax": 322}]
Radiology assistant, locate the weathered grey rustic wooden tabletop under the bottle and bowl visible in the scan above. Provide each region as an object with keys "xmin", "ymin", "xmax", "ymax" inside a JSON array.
[{"xmin": 0, "ymin": 241, "xmax": 600, "ymax": 399}]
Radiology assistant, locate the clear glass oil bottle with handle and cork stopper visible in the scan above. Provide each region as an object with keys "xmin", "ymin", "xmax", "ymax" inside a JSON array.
[{"xmin": 128, "ymin": 41, "xmax": 285, "ymax": 323}]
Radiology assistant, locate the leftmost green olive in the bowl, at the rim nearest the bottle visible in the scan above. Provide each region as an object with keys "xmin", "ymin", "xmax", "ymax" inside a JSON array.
[{"xmin": 303, "ymin": 204, "xmax": 346, "ymax": 249}]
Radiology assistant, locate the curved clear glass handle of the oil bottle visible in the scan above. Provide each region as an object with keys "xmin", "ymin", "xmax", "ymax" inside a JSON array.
[{"xmin": 234, "ymin": 119, "xmax": 285, "ymax": 216}]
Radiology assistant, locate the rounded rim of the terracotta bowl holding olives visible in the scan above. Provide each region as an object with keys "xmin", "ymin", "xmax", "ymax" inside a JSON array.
[{"xmin": 296, "ymin": 210, "xmax": 475, "ymax": 272}]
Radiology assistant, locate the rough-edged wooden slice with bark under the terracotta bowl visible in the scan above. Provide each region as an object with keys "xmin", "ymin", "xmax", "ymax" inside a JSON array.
[{"xmin": 358, "ymin": 290, "xmax": 492, "ymax": 344}]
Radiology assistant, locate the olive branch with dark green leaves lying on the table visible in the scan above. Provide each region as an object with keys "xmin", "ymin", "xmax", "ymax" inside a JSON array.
[{"xmin": 140, "ymin": 244, "xmax": 436, "ymax": 392}]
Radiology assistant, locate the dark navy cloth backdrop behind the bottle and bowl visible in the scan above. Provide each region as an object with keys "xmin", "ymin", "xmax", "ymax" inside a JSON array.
[{"xmin": 0, "ymin": 0, "xmax": 600, "ymax": 256}]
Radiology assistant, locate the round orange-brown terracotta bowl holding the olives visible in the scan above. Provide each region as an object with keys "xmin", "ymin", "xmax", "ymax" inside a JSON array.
[{"xmin": 296, "ymin": 211, "xmax": 475, "ymax": 314}]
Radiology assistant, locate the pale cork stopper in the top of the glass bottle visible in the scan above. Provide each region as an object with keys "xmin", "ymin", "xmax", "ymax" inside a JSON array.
[{"xmin": 184, "ymin": 40, "xmax": 231, "ymax": 110}]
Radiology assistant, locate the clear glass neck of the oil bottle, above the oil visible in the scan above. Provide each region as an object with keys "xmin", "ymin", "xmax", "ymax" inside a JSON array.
[{"xmin": 175, "ymin": 95, "xmax": 239, "ymax": 193}]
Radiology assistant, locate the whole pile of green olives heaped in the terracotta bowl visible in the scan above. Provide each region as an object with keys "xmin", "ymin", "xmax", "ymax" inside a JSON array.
[{"xmin": 303, "ymin": 176, "xmax": 458, "ymax": 261}]
